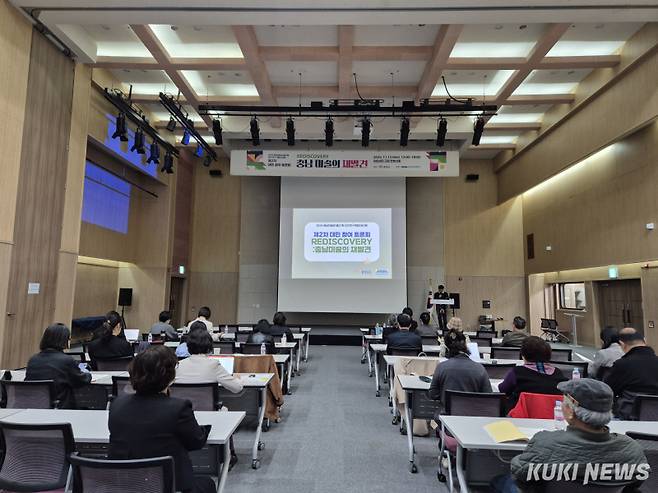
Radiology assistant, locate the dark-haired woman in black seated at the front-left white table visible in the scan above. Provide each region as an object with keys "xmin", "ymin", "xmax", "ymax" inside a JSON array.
[{"xmin": 108, "ymin": 345, "xmax": 215, "ymax": 493}]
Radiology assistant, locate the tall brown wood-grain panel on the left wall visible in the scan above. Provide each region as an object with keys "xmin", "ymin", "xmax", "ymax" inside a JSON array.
[{"xmin": 2, "ymin": 31, "xmax": 74, "ymax": 367}]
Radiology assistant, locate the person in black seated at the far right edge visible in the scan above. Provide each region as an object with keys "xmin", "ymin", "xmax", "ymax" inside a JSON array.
[{"xmin": 605, "ymin": 327, "xmax": 658, "ymax": 419}]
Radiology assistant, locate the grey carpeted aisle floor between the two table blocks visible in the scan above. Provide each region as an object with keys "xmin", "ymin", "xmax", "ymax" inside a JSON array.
[{"xmin": 226, "ymin": 346, "xmax": 447, "ymax": 493}]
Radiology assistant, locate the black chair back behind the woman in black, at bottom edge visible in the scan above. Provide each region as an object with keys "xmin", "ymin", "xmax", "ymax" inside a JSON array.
[{"xmin": 71, "ymin": 454, "xmax": 175, "ymax": 493}]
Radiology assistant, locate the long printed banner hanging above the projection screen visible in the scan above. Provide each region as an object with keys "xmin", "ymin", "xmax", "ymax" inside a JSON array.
[{"xmin": 231, "ymin": 149, "xmax": 459, "ymax": 177}]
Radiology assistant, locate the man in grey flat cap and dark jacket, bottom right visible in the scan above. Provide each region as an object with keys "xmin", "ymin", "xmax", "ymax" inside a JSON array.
[{"xmin": 493, "ymin": 378, "xmax": 649, "ymax": 493}]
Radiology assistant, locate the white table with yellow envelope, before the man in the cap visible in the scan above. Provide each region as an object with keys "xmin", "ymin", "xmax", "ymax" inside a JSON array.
[{"xmin": 440, "ymin": 416, "xmax": 658, "ymax": 493}]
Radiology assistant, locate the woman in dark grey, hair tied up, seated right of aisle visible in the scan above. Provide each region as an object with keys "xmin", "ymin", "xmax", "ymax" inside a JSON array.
[{"xmin": 428, "ymin": 330, "xmax": 491, "ymax": 407}]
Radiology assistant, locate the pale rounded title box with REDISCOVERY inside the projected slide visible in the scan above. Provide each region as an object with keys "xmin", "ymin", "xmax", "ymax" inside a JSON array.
[{"xmin": 304, "ymin": 221, "xmax": 379, "ymax": 263}]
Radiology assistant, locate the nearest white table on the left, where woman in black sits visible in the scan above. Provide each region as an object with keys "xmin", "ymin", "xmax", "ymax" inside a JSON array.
[{"xmin": 0, "ymin": 409, "xmax": 245, "ymax": 493}]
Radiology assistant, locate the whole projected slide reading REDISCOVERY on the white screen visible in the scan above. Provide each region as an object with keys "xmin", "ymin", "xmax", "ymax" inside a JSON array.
[{"xmin": 292, "ymin": 209, "xmax": 392, "ymax": 279}]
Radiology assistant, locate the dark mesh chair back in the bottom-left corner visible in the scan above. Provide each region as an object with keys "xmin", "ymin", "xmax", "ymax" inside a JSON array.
[{"xmin": 0, "ymin": 422, "xmax": 75, "ymax": 491}]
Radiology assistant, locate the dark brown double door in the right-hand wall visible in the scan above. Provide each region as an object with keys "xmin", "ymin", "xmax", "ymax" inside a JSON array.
[{"xmin": 597, "ymin": 279, "xmax": 644, "ymax": 332}]
